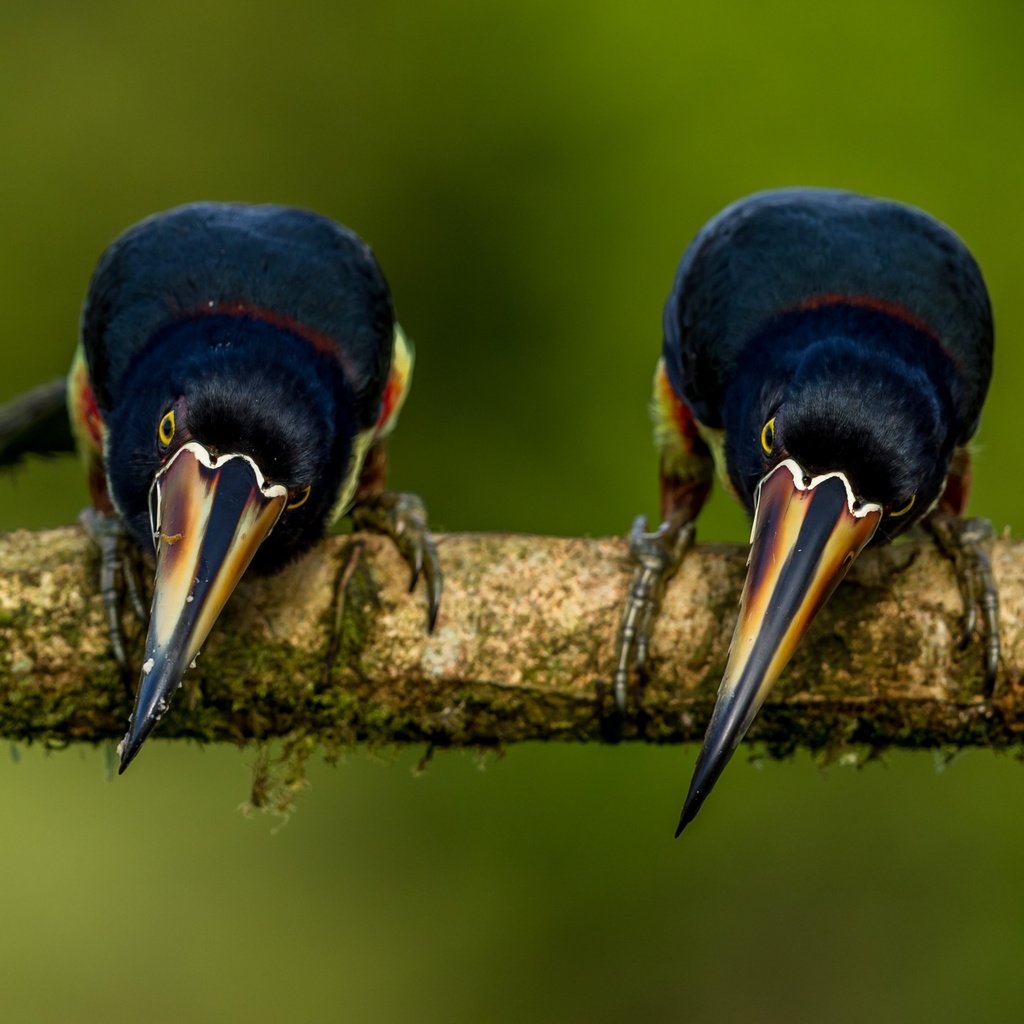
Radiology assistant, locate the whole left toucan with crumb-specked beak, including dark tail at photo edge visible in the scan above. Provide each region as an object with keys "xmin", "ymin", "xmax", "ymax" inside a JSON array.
[{"xmin": 0, "ymin": 203, "xmax": 442, "ymax": 772}]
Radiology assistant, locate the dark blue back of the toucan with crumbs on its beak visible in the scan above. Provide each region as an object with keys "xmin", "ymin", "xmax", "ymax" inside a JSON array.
[{"xmin": 82, "ymin": 203, "xmax": 394, "ymax": 429}]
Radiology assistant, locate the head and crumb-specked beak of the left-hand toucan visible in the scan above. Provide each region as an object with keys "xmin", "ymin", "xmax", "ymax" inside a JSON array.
[{"xmin": 105, "ymin": 316, "xmax": 357, "ymax": 771}]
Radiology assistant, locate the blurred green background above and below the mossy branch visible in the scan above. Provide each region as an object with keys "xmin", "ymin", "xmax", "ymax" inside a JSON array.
[{"xmin": 0, "ymin": 0, "xmax": 1024, "ymax": 1024}]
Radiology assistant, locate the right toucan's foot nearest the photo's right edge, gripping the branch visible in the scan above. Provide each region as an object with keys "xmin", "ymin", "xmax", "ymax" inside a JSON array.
[{"xmin": 925, "ymin": 512, "xmax": 999, "ymax": 696}]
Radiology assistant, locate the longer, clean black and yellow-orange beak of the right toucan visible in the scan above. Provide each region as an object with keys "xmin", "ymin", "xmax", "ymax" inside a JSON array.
[{"xmin": 676, "ymin": 459, "xmax": 882, "ymax": 836}]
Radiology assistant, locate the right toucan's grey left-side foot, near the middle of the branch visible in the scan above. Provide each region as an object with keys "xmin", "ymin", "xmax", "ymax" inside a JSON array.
[{"xmin": 612, "ymin": 516, "xmax": 694, "ymax": 714}]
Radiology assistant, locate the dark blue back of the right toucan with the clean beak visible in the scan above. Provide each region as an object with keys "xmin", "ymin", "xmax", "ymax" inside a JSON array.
[{"xmin": 664, "ymin": 188, "xmax": 992, "ymax": 443}]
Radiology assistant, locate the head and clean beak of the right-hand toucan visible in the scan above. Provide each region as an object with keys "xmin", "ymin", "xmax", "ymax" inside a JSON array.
[{"xmin": 679, "ymin": 305, "xmax": 957, "ymax": 830}]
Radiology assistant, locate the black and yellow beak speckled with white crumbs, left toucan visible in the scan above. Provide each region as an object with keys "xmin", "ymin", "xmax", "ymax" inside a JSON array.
[{"xmin": 118, "ymin": 441, "xmax": 288, "ymax": 773}]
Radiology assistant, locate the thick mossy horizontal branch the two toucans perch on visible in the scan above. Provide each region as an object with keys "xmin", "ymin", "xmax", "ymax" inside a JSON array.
[{"xmin": 0, "ymin": 527, "xmax": 1024, "ymax": 753}]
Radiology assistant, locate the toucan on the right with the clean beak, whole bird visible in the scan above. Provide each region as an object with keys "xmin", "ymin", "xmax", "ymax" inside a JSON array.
[{"xmin": 612, "ymin": 187, "xmax": 999, "ymax": 837}]
